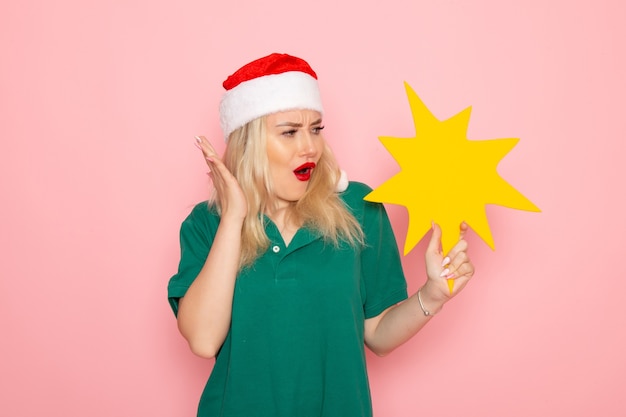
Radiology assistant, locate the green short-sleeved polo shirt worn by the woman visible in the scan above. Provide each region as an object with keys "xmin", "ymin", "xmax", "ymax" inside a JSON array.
[{"xmin": 168, "ymin": 182, "xmax": 407, "ymax": 417}]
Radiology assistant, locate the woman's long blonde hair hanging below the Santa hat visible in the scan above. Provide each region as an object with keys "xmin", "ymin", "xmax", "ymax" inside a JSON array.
[{"xmin": 213, "ymin": 117, "xmax": 364, "ymax": 268}]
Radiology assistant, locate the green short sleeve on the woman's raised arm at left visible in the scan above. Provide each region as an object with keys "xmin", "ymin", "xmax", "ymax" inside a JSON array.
[{"xmin": 167, "ymin": 201, "xmax": 219, "ymax": 315}]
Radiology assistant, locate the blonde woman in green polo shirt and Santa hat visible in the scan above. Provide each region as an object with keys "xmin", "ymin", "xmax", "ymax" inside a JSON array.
[{"xmin": 168, "ymin": 54, "xmax": 474, "ymax": 417}]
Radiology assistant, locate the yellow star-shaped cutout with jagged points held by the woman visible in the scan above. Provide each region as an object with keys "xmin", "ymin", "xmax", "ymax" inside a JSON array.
[{"xmin": 365, "ymin": 83, "xmax": 540, "ymax": 255}]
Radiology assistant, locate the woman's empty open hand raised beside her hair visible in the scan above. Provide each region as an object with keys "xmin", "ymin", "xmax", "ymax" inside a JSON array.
[{"xmin": 195, "ymin": 136, "xmax": 248, "ymax": 221}]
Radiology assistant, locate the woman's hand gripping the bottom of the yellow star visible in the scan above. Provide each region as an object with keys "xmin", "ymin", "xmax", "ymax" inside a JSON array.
[{"xmin": 421, "ymin": 222, "xmax": 474, "ymax": 304}]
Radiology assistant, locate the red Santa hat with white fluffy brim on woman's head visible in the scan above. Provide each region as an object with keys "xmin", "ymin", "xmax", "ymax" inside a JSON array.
[{"xmin": 220, "ymin": 53, "xmax": 323, "ymax": 140}]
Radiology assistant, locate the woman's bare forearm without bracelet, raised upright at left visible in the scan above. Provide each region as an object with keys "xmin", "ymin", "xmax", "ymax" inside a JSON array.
[{"xmin": 178, "ymin": 219, "xmax": 241, "ymax": 358}]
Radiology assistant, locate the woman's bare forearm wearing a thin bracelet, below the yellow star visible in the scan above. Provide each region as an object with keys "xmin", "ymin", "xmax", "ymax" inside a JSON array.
[{"xmin": 366, "ymin": 285, "xmax": 446, "ymax": 356}]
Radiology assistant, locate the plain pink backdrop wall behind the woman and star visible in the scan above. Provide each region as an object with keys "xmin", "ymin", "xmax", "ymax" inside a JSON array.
[{"xmin": 0, "ymin": 0, "xmax": 626, "ymax": 417}]
